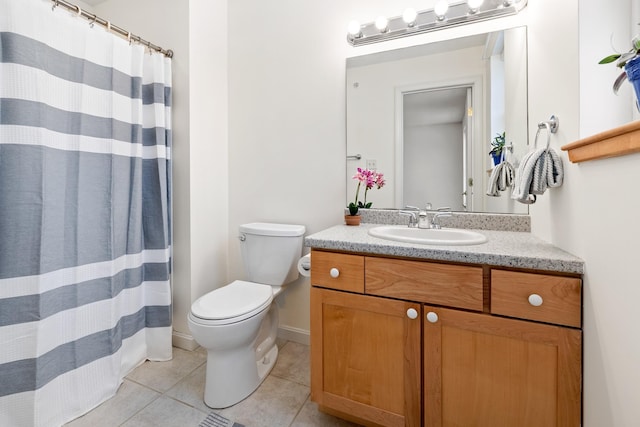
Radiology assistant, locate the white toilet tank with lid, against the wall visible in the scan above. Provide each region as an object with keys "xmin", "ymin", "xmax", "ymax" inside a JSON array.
[{"xmin": 240, "ymin": 222, "xmax": 306, "ymax": 286}]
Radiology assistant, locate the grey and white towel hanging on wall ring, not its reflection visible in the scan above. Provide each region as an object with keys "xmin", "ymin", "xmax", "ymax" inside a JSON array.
[{"xmin": 511, "ymin": 148, "xmax": 564, "ymax": 204}]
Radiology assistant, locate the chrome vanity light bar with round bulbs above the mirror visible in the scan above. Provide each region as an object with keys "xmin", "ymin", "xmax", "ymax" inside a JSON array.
[{"xmin": 347, "ymin": 0, "xmax": 527, "ymax": 46}]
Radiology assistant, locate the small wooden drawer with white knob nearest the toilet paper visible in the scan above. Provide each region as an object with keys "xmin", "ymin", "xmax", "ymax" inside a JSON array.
[{"xmin": 311, "ymin": 250, "xmax": 364, "ymax": 294}]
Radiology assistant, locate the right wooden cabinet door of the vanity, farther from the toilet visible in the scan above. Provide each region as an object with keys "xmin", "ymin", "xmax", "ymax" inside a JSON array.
[{"xmin": 423, "ymin": 306, "xmax": 582, "ymax": 427}]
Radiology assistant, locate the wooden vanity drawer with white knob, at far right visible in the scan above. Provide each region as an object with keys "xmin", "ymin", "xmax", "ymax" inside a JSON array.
[{"xmin": 491, "ymin": 270, "xmax": 582, "ymax": 328}]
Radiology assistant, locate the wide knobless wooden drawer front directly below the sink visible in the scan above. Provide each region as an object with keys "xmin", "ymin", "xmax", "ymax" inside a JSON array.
[{"xmin": 365, "ymin": 257, "xmax": 483, "ymax": 311}]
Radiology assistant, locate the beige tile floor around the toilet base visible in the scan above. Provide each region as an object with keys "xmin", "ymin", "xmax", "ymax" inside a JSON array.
[{"xmin": 65, "ymin": 341, "xmax": 364, "ymax": 427}]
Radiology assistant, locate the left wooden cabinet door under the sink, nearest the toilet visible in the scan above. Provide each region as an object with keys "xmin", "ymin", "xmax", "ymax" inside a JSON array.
[{"xmin": 311, "ymin": 287, "xmax": 422, "ymax": 427}]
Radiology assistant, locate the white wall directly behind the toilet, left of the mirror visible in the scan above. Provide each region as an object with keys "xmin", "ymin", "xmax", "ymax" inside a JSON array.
[{"xmin": 229, "ymin": 0, "xmax": 347, "ymax": 334}]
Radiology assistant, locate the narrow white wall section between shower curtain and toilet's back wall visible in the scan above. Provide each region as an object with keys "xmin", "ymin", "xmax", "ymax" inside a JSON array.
[{"xmin": 188, "ymin": 0, "xmax": 229, "ymax": 338}]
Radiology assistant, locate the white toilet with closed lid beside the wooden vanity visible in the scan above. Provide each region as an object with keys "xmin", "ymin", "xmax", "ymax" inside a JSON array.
[{"xmin": 188, "ymin": 222, "xmax": 306, "ymax": 408}]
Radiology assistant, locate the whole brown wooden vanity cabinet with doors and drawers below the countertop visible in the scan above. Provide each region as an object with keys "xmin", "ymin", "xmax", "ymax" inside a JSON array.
[{"xmin": 311, "ymin": 249, "xmax": 582, "ymax": 427}]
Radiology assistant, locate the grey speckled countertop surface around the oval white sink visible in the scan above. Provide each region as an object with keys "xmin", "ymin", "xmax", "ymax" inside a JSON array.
[{"xmin": 305, "ymin": 223, "xmax": 584, "ymax": 274}]
